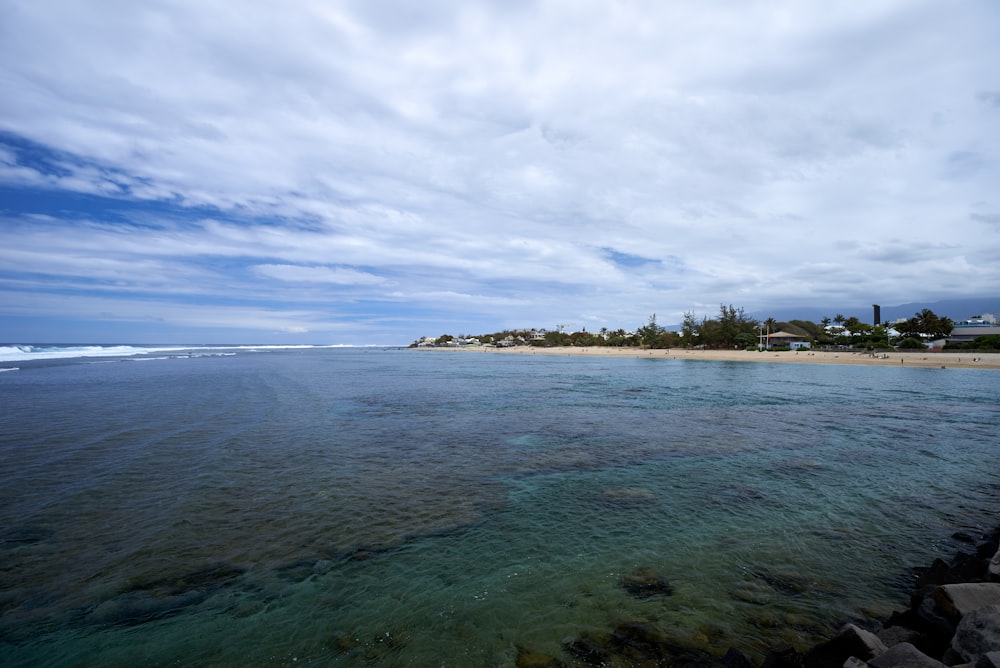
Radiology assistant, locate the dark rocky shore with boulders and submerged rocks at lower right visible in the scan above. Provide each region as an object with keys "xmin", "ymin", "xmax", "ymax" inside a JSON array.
[{"xmin": 516, "ymin": 527, "xmax": 1000, "ymax": 668}]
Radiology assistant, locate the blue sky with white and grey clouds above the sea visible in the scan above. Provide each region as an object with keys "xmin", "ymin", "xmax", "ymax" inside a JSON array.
[{"xmin": 0, "ymin": 0, "xmax": 1000, "ymax": 345}]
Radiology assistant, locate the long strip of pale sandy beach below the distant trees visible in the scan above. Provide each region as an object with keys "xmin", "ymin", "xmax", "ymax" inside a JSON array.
[{"xmin": 421, "ymin": 346, "xmax": 1000, "ymax": 370}]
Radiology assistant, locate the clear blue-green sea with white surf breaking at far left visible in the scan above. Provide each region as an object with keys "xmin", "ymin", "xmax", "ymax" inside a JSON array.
[{"xmin": 0, "ymin": 346, "xmax": 1000, "ymax": 666}]
